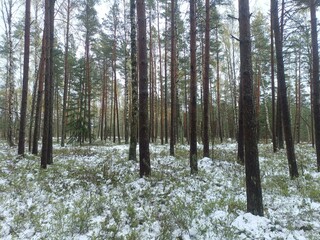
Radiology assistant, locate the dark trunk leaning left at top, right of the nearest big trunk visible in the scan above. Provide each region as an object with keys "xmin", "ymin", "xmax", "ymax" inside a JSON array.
[{"xmin": 271, "ymin": 0, "xmax": 299, "ymax": 178}]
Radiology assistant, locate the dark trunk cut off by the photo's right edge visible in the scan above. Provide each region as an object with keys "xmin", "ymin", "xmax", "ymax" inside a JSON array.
[{"xmin": 310, "ymin": 0, "xmax": 320, "ymax": 172}]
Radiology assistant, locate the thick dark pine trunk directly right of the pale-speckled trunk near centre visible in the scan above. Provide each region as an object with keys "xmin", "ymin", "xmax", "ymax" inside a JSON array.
[{"xmin": 137, "ymin": 0, "xmax": 151, "ymax": 177}]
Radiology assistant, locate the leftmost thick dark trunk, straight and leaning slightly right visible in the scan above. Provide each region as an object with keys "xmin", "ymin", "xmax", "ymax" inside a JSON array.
[{"xmin": 18, "ymin": 0, "xmax": 31, "ymax": 155}]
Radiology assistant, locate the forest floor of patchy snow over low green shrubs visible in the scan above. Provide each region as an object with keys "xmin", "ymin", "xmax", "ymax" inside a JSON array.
[{"xmin": 0, "ymin": 142, "xmax": 320, "ymax": 240}]
